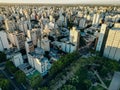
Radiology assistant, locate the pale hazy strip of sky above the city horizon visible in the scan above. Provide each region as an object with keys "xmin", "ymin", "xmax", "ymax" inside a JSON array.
[{"xmin": 0, "ymin": 0, "xmax": 120, "ymax": 5}]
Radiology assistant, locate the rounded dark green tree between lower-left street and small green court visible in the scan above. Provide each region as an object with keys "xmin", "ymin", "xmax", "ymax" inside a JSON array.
[{"xmin": 15, "ymin": 70, "xmax": 26, "ymax": 83}]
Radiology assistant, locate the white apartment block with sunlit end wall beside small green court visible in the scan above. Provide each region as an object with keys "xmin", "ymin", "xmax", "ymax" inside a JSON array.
[{"xmin": 28, "ymin": 48, "xmax": 50, "ymax": 76}]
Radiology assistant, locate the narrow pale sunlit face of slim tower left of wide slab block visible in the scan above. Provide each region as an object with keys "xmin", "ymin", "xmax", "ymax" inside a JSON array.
[{"xmin": 96, "ymin": 24, "xmax": 107, "ymax": 51}]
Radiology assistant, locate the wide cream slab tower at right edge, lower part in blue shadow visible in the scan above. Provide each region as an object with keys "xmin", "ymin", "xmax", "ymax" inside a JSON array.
[{"xmin": 104, "ymin": 28, "xmax": 120, "ymax": 61}]
